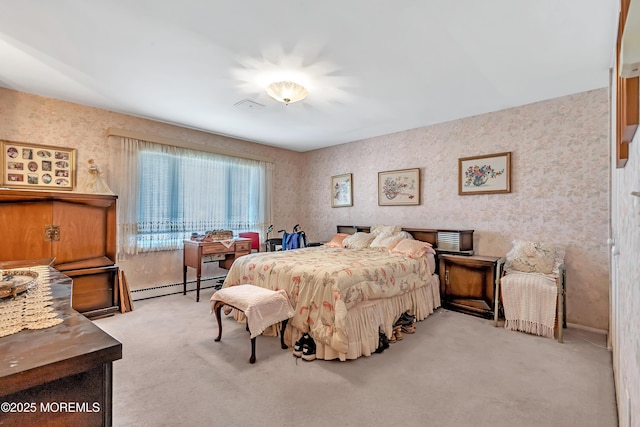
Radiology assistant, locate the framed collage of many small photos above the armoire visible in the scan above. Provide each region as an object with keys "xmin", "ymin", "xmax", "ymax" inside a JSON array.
[{"xmin": 0, "ymin": 141, "xmax": 76, "ymax": 190}]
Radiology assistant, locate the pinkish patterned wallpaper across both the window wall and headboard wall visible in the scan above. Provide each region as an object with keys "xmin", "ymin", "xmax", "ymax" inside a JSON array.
[{"xmin": 0, "ymin": 89, "xmax": 609, "ymax": 329}]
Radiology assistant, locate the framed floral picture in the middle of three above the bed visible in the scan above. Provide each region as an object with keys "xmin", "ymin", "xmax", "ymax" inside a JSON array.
[{"xmin": 378, "ymin": 168, "xmax": 420, "ymax": 206}]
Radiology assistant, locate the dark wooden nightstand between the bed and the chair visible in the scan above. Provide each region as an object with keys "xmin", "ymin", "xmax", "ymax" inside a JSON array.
[{"xmin": 438, "ymin": 254, "xmax": 504, "ymax": 319}]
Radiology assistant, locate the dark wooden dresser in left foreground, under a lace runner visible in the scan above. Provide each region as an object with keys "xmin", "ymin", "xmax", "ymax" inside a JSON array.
[{"xmin": 0, "ymin": 269, "xmax": 122, "ymax": 426}]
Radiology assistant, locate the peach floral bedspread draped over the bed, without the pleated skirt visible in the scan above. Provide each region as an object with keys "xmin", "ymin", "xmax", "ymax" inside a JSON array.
[{"xmin": 223, "ymin": 246, "xmax": 432, "ymax": 353}]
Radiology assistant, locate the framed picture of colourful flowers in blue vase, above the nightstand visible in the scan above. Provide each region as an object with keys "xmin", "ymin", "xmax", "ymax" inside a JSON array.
[{"xmin": 458, "ymin": 152, "xmax": 511, "ymax": 195}]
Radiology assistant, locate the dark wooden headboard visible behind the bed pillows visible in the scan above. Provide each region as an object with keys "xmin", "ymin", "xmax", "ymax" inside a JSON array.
[{"xmin": 337, "ymin": 225, "xmax": 473, "ymax": 255}]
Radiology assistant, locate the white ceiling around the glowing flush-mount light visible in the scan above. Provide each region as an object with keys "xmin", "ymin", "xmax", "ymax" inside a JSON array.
[{"xmin": 0, "ymin": 0, "xmax": 619, "ymax": 151}]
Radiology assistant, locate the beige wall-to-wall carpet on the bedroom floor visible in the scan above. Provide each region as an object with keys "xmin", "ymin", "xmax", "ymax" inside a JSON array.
[{"xmin": 95, "ymin": 289, "xmax": 618, "ymax": 427}]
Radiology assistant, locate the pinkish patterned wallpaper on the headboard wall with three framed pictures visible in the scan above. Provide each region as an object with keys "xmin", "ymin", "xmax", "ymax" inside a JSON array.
[{"xmin": 302, "ymin": 89, "xmax": 609, "ymax": 330}]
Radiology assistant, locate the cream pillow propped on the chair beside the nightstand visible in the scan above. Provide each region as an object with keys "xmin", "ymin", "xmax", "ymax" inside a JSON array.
[{"xmin": 504, "ymin": 240, "xmax": 564, "ymax": 274}]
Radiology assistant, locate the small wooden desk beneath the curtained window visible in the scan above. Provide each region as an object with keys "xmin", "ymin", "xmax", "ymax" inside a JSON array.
[{"xmin": 182, "ymin": 237, "xmax": 251, "ymax": 302}]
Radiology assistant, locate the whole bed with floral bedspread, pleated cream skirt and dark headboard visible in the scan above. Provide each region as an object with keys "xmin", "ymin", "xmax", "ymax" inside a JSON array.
[{"xmin": 223, "ymin": 226, "xmax": 440, "ymax": 361}]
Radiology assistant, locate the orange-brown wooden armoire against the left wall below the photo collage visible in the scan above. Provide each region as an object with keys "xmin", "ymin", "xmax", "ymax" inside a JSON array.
[{"xmin": 0, "ymin": 190, "xmax": 119, "ymax": 318}]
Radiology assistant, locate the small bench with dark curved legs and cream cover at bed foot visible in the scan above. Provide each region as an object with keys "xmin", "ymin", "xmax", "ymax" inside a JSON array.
[{"xmin": 211, "ymin": 285, "xmax": 294, "ymax": 363}]
